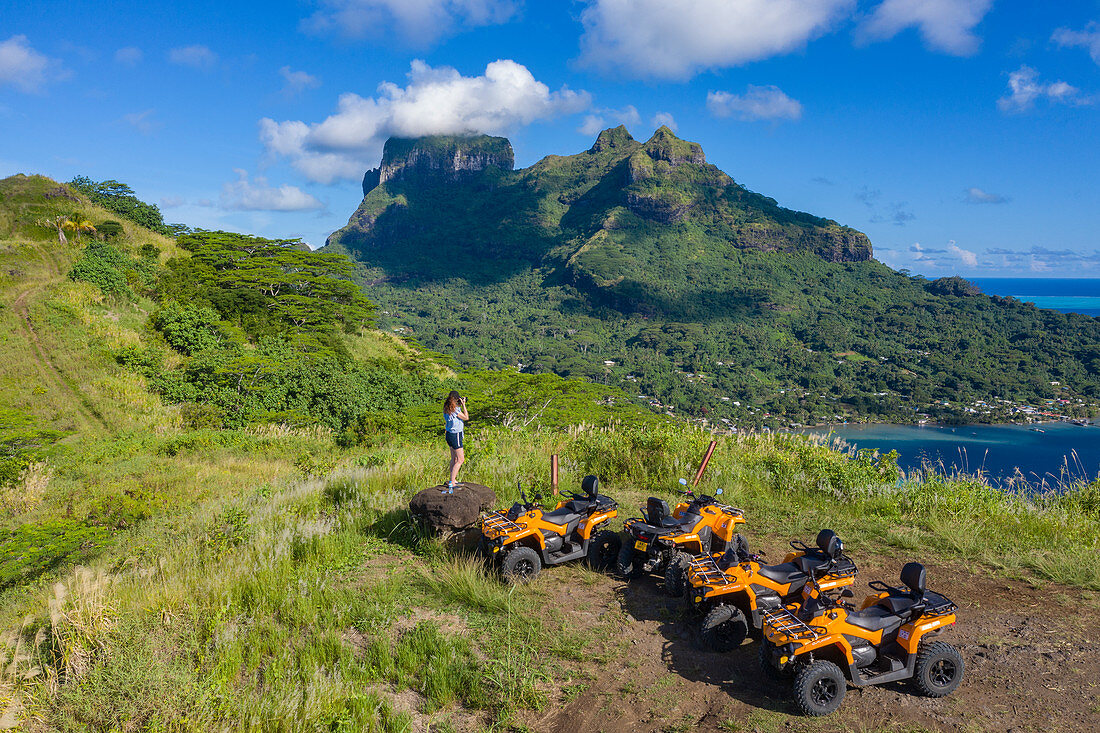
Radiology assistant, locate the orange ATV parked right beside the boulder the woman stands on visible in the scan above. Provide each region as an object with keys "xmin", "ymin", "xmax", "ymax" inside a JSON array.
[{"xmin": 479, "ymin": 475, "xmax": 619, "ymax": 582}]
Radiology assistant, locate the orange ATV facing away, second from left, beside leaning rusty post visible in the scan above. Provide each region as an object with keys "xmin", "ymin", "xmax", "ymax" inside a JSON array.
[{"xmin": 618, "ymin": 479, "xmax": 745, "ymax": 595}]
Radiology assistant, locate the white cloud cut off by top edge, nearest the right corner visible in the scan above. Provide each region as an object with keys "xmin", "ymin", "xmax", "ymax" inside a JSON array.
[{"xmin": 858, "ymin": 0, "xmax": 993, "ymax": 56}]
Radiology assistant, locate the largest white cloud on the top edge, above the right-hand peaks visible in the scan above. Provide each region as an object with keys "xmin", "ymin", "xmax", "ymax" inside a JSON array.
[{"xmin": 581, "ymin": 0, "xmax": 856, "ymax": 79}]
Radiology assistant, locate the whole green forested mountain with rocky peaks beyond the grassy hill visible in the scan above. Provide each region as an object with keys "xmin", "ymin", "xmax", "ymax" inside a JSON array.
[{"xmin": 329, "ymin": 128, "xmax": 1100, "ymax": 425}]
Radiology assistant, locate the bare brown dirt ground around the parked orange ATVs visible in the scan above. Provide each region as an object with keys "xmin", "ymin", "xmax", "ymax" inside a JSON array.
[{"xmin": 518, "ymin": 559, "xmax": 1100, "ymax": 733}]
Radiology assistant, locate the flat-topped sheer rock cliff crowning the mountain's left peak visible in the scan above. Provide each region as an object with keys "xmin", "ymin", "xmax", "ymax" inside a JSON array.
[{"xmin": 363, "ymin": 135, "xmax": 515, "ymax": 196}]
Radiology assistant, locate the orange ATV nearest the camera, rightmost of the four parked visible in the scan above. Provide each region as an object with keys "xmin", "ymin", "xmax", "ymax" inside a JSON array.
[{"xmin": 760, "ymin": 562, "xmax": 963, "ymax": 715}]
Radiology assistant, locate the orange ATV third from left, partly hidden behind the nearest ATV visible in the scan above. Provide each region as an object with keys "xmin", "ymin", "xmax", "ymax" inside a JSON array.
[{"xmin": 686, "ymin": 529, "xmax": 856, "ymax": 652}]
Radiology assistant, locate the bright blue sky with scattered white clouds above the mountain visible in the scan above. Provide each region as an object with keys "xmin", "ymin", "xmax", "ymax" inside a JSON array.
[{"xmin": 0, "ymin": 0, "xmax": 1100, "ymax": 277}]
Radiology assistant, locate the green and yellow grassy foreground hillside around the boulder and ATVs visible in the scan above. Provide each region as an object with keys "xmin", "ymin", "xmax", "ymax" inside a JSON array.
[{"xmin": 0, "ymin": 172, "xmax": 1100, "ymax": 732}]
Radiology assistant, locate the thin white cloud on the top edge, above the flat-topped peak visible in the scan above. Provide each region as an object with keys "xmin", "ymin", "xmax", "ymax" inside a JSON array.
[{"xmin": 303, "ymin": 0, "xmax": 516, "ymax": 47}]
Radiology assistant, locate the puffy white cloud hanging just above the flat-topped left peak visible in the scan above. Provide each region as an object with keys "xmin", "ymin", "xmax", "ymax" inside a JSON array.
[{"xmin": 260, "ymin": 59, "xmax": 590, "ymax": 183}]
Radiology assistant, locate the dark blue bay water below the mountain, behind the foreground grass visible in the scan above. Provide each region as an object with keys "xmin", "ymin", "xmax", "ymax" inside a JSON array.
[{"xmin": 807, "ymin": 423, "xmax": 1100, "ymax": 486}]
